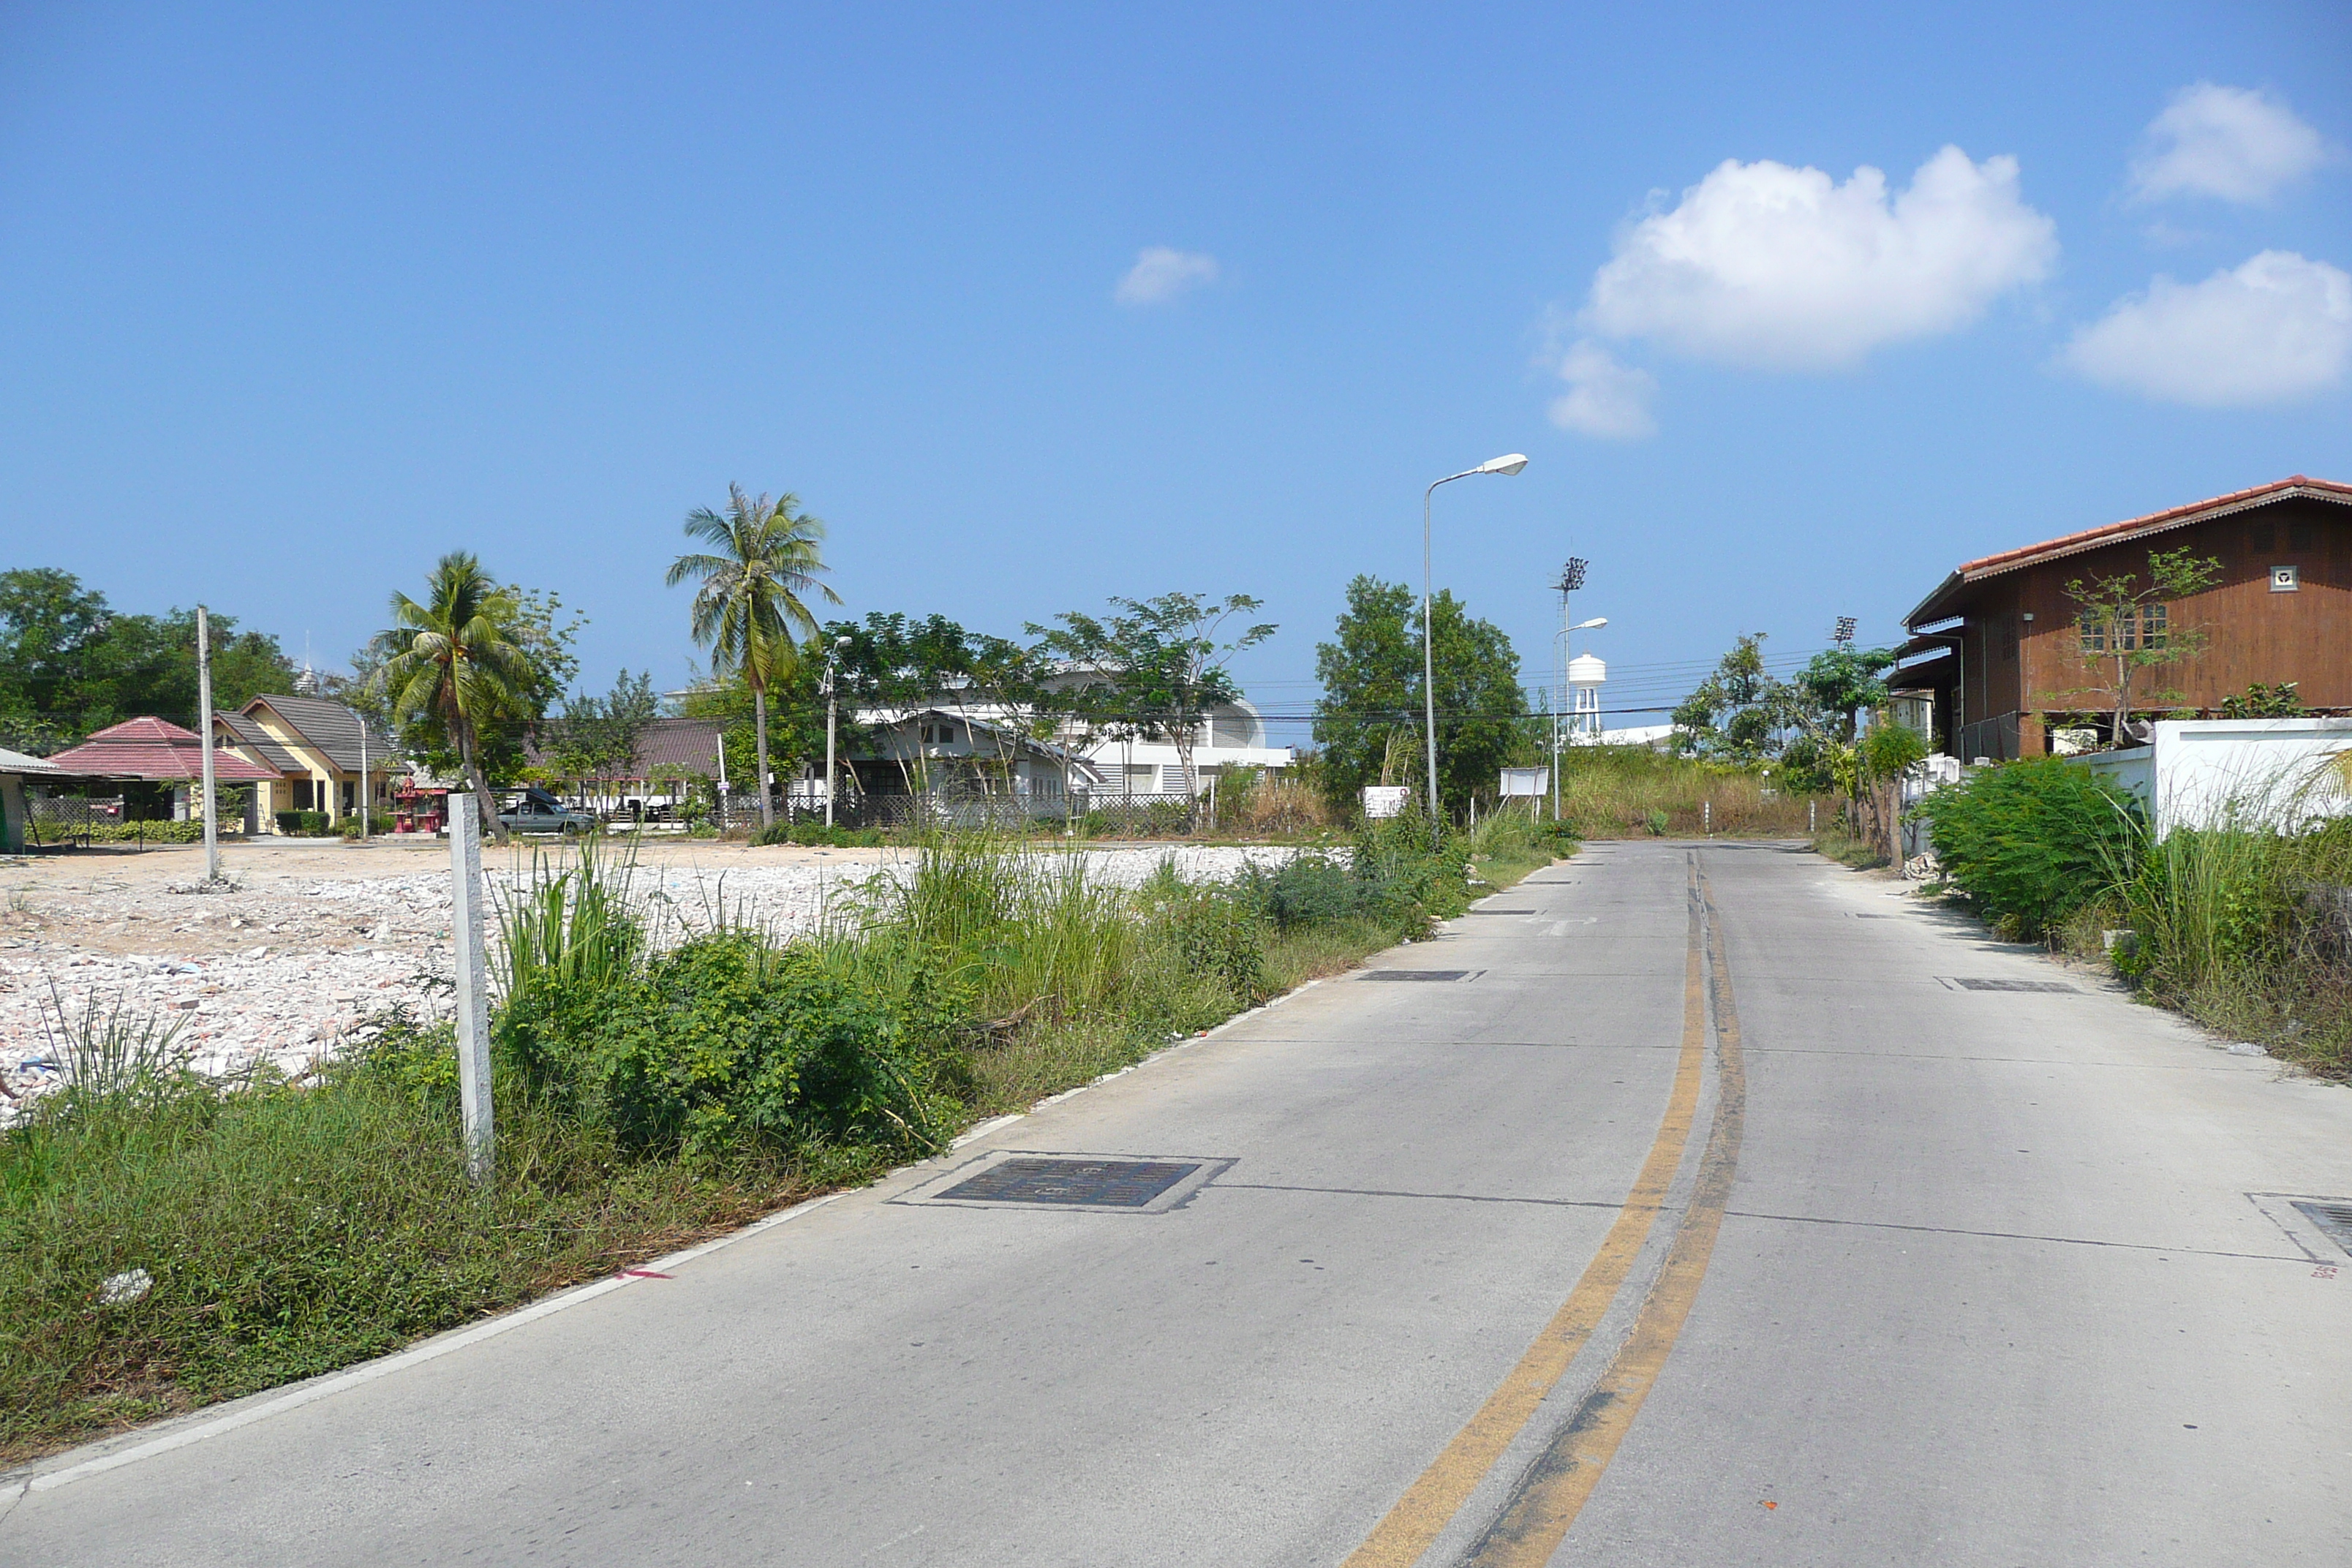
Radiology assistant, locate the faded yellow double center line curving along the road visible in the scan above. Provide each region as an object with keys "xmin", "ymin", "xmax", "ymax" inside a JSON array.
[{"xmin": 1346, "ymin": 856, "xmax": 1747, "ymax": 1568}]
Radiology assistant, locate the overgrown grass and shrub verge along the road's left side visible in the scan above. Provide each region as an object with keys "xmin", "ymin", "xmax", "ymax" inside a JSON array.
[{"xmin": 0, "ymin": 818, "xmax": 1564, "ymax": 1462}]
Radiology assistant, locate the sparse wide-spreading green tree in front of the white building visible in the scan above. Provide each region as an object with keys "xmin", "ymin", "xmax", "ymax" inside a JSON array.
[{"xmin": 1028, "ymin": 592, "xmax": 1275, "ymax": 799}]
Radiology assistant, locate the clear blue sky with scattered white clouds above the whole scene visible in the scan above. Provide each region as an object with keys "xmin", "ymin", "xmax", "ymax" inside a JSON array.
[{"xmin": 0, "ymin": 0, "xmax": 2352, "ymax": 738}]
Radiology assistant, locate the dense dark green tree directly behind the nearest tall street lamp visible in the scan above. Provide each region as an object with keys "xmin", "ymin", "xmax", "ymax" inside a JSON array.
[{"xmin": 1315, "ymin": 576, "xmax": 1531, "ymax": 813}]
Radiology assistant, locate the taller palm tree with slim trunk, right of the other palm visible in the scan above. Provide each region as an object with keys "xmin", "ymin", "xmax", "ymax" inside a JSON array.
[{"xmin": 668, "ymin": 484, "xmax": 842, "ymax": 827}]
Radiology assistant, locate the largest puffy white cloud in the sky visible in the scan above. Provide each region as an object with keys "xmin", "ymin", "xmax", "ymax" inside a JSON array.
[{"xmin": 1586, "ymin": 146, "xmax": 2058, "ymax": 369}]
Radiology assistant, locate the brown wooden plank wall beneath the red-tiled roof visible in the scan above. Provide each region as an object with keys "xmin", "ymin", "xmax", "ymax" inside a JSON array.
[{"xmin": 1961, "ymin": 498, "xmax": 2352, "ymax": 750}]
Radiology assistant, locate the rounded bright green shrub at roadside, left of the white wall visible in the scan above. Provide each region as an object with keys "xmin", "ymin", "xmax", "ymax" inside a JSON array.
[{"xmin": 1919, "ymin": 757, "xmax": 2143, "ymax": 938}]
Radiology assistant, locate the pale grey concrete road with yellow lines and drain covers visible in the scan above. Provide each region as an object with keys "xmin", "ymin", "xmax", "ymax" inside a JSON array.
[{"xmin": 0, "ymin": 842, "xmax": 2352, "ymax": 1568}]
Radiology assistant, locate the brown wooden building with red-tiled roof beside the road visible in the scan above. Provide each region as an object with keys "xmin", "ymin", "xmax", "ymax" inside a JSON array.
[{"xmin": 1893, "ymin": 475, "xmax": 2352, "ymax": 759}]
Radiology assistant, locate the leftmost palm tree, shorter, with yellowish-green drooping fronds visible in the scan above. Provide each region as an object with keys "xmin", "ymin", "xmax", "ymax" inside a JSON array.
[{"xmin": 369, "ymin": 550, "xmax": 532, "ymax": 844}]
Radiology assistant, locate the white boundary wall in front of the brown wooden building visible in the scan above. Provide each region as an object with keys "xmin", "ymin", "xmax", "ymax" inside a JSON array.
[{"xmin": 2075, "ymin": 720, "xmax": 2352, "ymax": 840}]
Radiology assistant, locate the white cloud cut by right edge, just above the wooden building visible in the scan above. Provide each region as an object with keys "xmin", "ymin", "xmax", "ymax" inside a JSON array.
[{"xmin": 2060, "ymin": 252, "xmax": 2352, "ymax": 409}]
